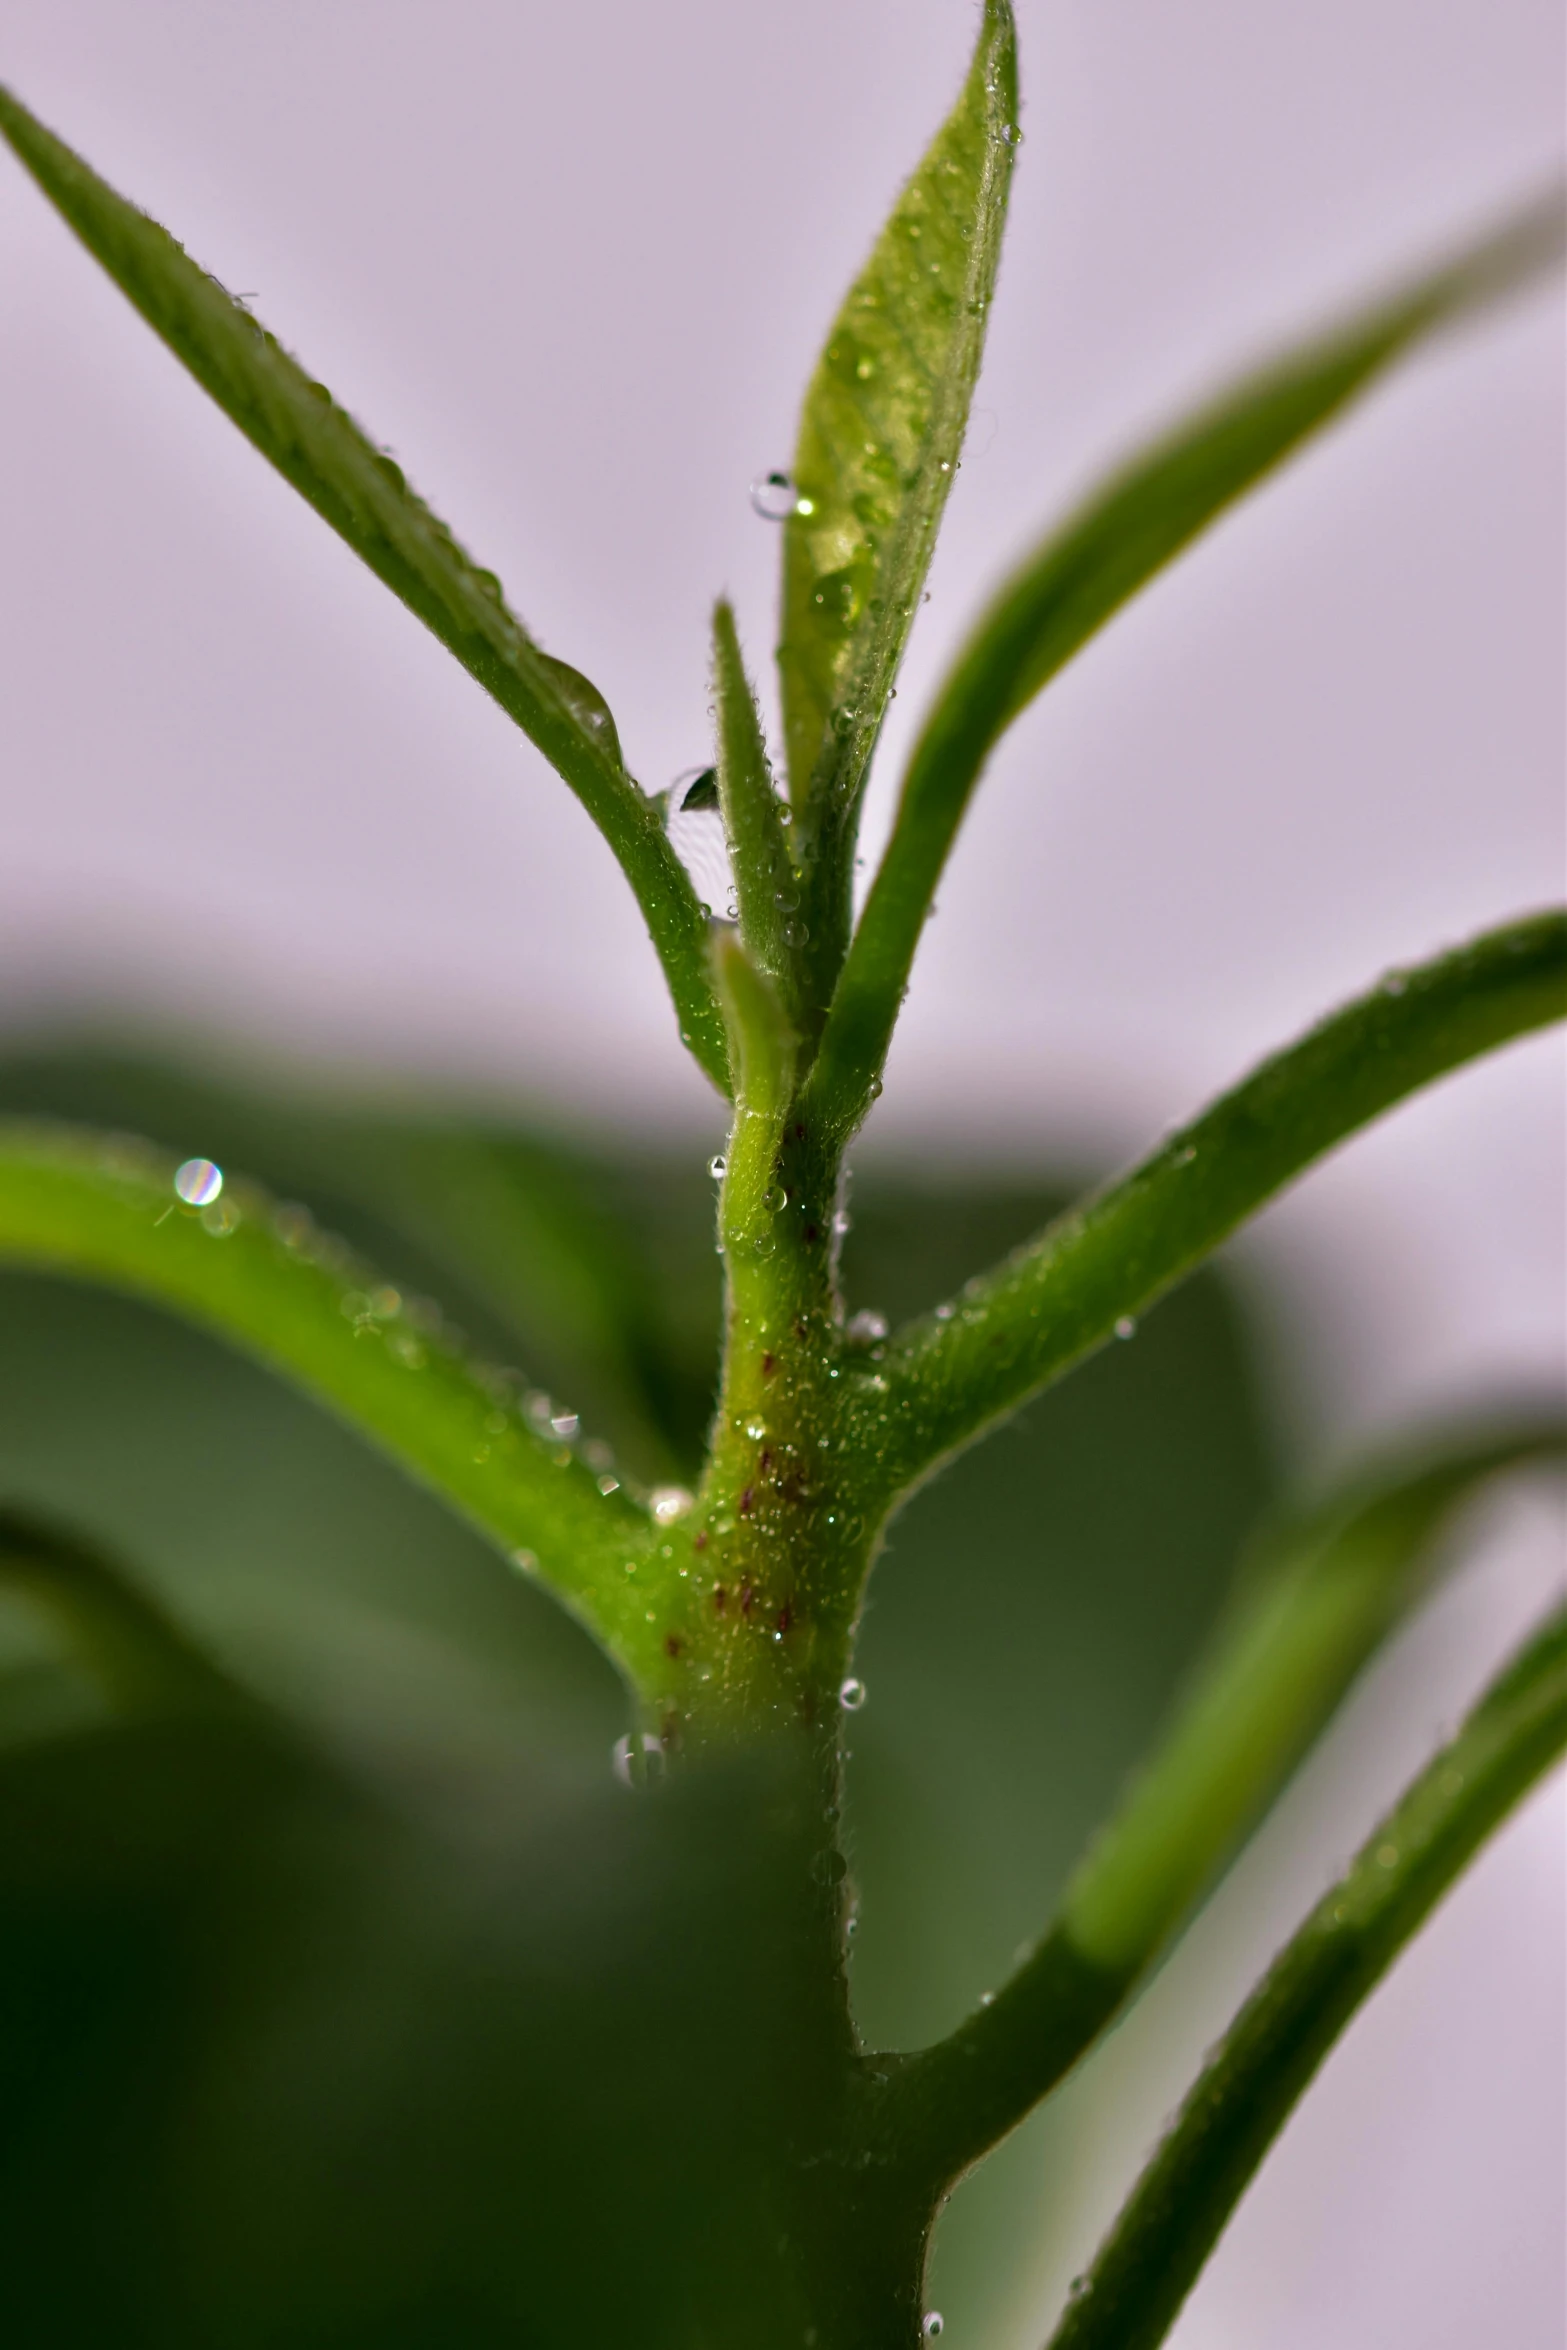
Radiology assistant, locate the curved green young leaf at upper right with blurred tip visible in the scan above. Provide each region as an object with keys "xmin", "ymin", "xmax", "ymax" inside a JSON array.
[{"xmin": 813, "ymin": 195, "xmax": 1562, "ymax": 1133}]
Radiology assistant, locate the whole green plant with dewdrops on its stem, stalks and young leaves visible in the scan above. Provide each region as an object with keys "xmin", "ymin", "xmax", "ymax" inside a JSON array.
[{"xmin": 0, "ymin": 0, "xmax": 1567, "ymax": 2350}]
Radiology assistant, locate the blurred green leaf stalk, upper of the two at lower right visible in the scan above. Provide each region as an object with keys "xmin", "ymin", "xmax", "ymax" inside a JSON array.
[{"xmin": 864, "ymin": 1415, "xmax": 1567, "ymax": 2186}]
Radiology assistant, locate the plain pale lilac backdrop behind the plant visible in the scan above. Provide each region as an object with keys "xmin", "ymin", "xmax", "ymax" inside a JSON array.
[{"xmin": 0, "ymin": 0, "xmax": 1567, "ymax": 2350}]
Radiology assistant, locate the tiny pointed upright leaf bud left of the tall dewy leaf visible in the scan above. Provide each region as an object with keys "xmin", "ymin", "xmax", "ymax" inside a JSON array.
[{"xmin": 718, "ymin": 602, "xmax": 799, "ymax": 1008}]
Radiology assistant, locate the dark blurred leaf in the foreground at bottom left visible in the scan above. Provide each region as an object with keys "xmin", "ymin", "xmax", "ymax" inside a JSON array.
[{"xmin": 0, "ymin": 1725, "xmax": 859, "ymax": 2350}]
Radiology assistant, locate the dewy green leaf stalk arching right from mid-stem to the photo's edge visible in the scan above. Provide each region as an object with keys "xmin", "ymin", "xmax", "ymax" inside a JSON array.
[{"xmin": 862, "ymin": 912, "xmax": 1567, "ymax": 1502}]
